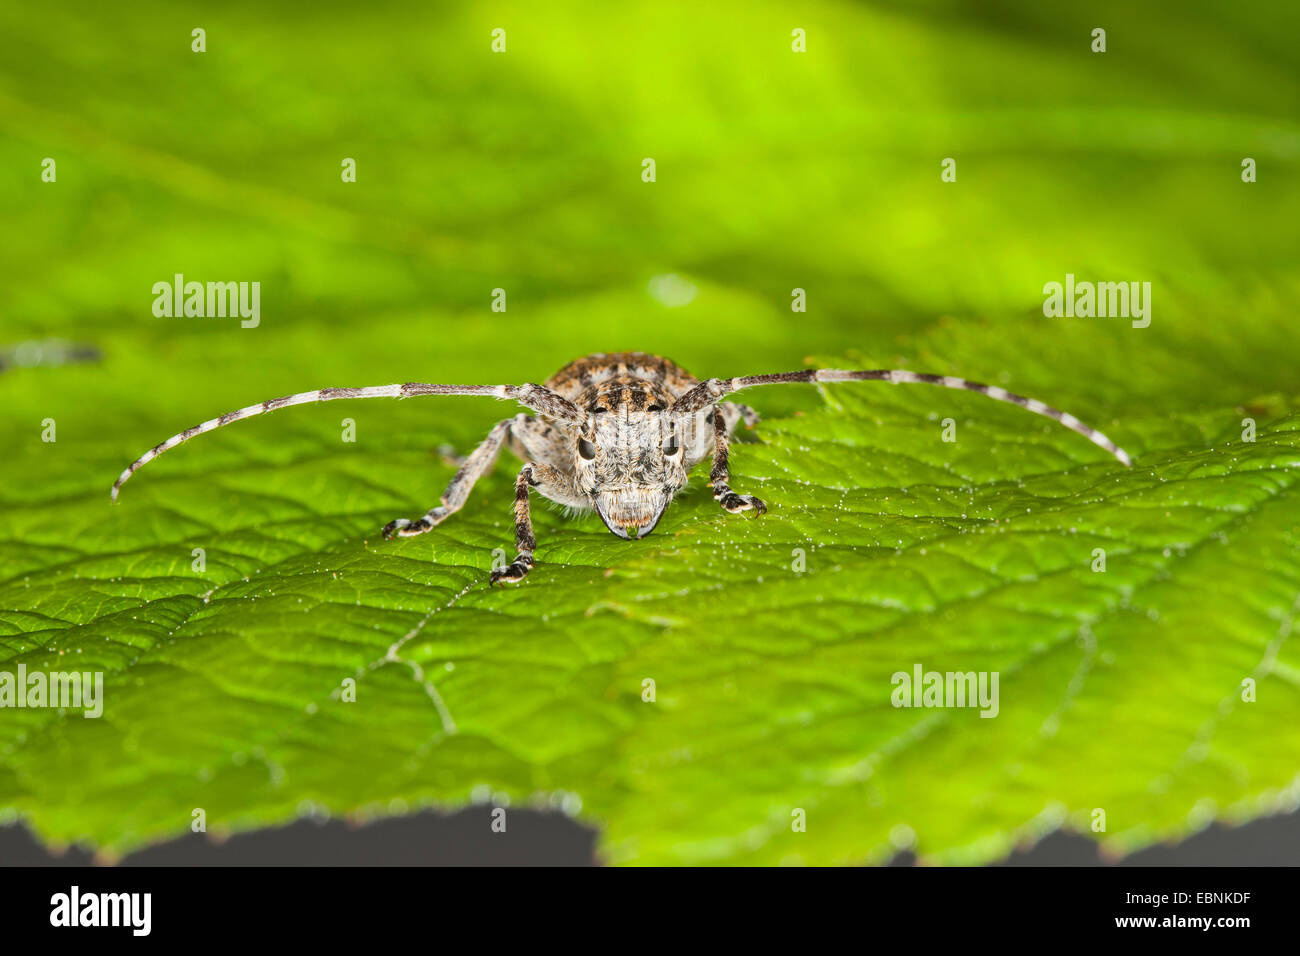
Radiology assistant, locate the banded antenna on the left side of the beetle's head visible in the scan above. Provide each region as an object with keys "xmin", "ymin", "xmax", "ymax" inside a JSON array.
[{"xmin": 108, "ymin": 382, "xmax": 586, "ymax": 501}]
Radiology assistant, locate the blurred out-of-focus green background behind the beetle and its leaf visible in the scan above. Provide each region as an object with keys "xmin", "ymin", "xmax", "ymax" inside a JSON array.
[{"xmin": 0, "ymin": 0, "xmax": 1300, "ymax": 868}]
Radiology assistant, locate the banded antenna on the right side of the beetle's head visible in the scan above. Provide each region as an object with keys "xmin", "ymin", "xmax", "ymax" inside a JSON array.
[{"xmin": 672, "ymin": 368, "xmax": 1134, "ymax": 467}]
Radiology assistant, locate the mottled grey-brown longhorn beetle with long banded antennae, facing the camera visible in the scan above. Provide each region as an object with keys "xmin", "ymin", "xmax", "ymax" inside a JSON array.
[{"xmin": 111, "ymin": 352, "xmax": 1132, "ymax": 584}]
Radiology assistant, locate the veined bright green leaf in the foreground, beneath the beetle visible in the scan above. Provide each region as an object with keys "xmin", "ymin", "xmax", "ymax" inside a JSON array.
[{"xmin": 0, "ymin": 345, "xmax": 1300, "ymax": 862}]
